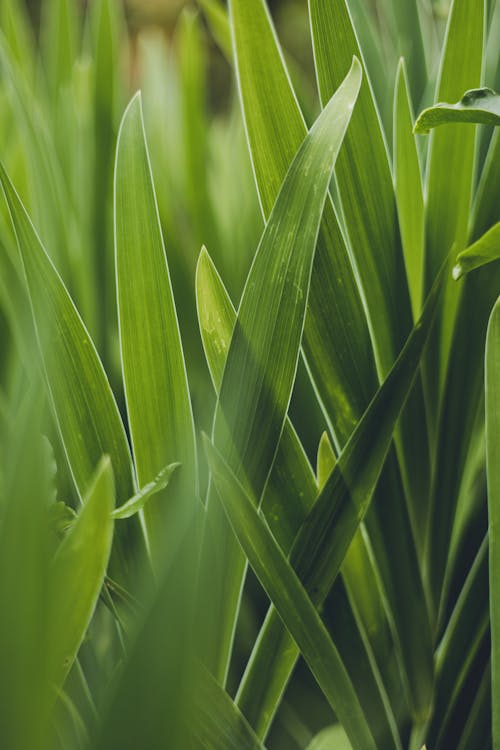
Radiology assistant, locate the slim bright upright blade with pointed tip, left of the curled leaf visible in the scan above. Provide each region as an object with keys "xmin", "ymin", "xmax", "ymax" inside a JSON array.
[{"xmin": 394, "ymin": 60, "xmax": 424, "ymax": 319}]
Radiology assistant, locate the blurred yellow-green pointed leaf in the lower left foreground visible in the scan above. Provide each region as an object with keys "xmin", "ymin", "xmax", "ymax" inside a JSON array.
[{"xmin": 48, "ymin": 458, "xmax": 115, "ymax": 687}]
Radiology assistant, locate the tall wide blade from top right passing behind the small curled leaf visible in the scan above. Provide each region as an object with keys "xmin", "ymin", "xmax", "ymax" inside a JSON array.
[{"xmin": 424, "ymin": 0, "xmax": 484, "ymax": 610}]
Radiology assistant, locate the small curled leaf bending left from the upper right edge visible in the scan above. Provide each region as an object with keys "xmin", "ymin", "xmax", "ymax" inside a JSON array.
[{"xmin": 415, "ymin": 88, "xmax": 500, "ymax": 134}]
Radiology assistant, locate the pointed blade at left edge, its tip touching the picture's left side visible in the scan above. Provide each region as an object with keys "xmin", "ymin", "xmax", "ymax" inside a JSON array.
[{"xmin": 0, "ymin": 167, "xmax": 134, "ymax": 512}]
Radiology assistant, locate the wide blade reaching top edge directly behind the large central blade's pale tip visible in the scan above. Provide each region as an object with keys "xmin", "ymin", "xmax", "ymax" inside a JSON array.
[{"xmin": 309, "ymin": 0, "xmax": 412, "ymax": 378}]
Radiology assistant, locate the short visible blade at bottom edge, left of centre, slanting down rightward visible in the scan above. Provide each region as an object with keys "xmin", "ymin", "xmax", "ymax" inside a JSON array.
[{"xmin": 191, "ymin": 667, "xmax": 264, "ymax": 750}]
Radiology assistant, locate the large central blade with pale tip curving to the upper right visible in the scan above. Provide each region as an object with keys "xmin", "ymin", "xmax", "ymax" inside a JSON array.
[{"xmin": 201, "ymin": 60, "xmax": 361, "ymax": 682}]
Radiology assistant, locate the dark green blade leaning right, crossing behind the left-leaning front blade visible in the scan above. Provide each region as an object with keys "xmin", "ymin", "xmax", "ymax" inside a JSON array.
[{"xmin": 236, "ymin": 270, "xmax": 439, "ymax": 736}]
